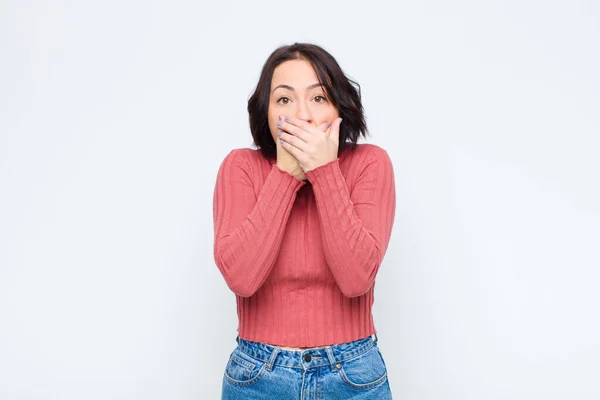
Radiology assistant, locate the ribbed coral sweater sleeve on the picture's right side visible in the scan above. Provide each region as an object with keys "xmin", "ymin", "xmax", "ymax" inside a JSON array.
[{"xmin": 304, "ymin": 147, "xmax": 396, "ymax": 297}]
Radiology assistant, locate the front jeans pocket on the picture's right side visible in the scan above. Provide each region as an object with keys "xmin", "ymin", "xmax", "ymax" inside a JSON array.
[{"xmin": 338, "ymin": 345, "xmax": 387, "ymax": 389}]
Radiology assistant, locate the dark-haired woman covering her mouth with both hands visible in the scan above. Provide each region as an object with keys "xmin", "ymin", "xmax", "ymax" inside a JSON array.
[{"xmin": 213, "ymin": 43, "xmax": 396, "ymax": 400}]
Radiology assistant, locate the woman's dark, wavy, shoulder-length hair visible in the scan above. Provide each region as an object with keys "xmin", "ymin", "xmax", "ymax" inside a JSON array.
[{"xmin": 248, "ymin": 43, "xmax": 369, "ymax": 159}]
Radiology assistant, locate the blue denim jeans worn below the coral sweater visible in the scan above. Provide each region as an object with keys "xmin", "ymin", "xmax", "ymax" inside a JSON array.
[{"xmin": 221, "ymin": 334, "xmax": 392, "ymax": 400}]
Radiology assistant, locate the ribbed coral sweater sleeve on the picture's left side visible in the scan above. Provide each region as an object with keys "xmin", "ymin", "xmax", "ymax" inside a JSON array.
[{"xmin": 213, "ymin": 149, "xmax": 306, "ymax": 297}]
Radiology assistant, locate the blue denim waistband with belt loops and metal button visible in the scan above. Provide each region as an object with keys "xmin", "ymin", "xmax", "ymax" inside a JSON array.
[{"xmin": 236, "ymin": 333, "xmax": 377, "ymax": 371}]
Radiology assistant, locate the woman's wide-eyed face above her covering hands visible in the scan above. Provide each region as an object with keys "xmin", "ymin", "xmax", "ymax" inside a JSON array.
[{"xmin": 268, "ymin": 60, "xmax": 339, "ymax": 141}]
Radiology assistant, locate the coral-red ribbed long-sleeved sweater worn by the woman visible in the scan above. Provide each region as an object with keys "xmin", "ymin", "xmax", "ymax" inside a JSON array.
[{"xmin": 213, "ymin": 144, "xmax": 396, "ymax": 347}]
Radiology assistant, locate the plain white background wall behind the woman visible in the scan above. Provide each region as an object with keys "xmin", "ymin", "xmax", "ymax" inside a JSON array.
[{"xmin": 0, "ymin": 0, "xmax": 600, "ymax": 400}]
